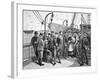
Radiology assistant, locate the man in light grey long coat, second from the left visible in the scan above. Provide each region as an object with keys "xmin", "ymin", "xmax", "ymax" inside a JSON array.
[{"xmin": 37, "ymin": 33, "xmax": 44, "ymax": 66}]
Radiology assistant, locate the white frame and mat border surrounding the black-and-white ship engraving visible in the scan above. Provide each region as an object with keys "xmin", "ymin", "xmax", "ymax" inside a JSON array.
[{"xmin": 11, "ymin": 2, "xmax": 97, "ymax": 78}]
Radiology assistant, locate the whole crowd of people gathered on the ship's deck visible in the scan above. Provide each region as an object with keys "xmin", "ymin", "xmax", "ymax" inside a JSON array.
[{"xmin": 31, "ymin": 31, "xmax": 91, "ymax": 66}]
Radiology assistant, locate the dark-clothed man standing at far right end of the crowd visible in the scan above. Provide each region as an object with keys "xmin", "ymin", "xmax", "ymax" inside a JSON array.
[{"xmin": 78, "ymin": 34, "xmax": 89, "ymax": 66}]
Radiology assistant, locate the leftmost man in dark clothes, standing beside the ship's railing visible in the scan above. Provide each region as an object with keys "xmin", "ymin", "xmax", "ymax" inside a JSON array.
[{"xmin": 31, "ymin": 31, "xmax": 38, "ymax": 60}]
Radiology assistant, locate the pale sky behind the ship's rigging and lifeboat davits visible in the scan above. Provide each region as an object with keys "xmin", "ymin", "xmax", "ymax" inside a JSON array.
[{"xmin": 24, "ymin": 10, "xmax": 90, "ymax": 31}]
